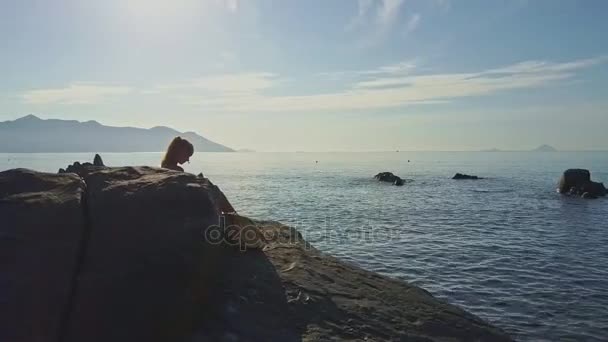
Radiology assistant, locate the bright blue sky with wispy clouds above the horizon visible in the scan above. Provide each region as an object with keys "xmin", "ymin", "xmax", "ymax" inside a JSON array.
[{"xmin": 0, "ymin": 0, "xmax": 608, "ymax": 151}]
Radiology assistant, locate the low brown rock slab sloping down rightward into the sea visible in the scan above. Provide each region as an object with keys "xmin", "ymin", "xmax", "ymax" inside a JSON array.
[{"xmin": 194, "ymin": 222, "xmax": 511, "ymax": 342}]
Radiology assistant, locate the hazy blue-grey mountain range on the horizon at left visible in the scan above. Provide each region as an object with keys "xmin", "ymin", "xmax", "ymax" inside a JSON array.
[{"xmin": 0, "ymin": 115, "xmax": 234, "ymax": 152}]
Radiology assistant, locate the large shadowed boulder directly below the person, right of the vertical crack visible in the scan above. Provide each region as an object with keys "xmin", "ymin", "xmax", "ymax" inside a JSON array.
[{"xmin": 64, "ymin": 165, "xmax": 232, "ymax": 342}]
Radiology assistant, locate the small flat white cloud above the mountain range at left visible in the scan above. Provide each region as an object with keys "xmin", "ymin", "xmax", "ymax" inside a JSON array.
[{"xmin": 22, "ymin": 83, "xmax": 132, "ymax": 104}]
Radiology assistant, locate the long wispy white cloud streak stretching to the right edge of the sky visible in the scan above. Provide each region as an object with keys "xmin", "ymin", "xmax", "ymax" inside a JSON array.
[{"xmin": 158, "ymin": 57, "xmax": 605, "ymax": 113}]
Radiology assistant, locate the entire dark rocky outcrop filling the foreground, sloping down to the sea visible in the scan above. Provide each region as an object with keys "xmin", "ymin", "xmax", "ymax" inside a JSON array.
[{"xmin": 0, "ymin": 165, "xmax": 510, "ymax": 342}]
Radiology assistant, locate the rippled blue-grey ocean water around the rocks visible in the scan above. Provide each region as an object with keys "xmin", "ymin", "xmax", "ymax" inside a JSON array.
[{"xmin": 0, "ymin": 152, "xmax": 608, "ymax": 341}]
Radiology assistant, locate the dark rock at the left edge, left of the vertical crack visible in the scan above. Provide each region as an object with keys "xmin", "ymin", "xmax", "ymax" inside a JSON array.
[{"xmin": 0, "ymin": 169, "xmax": 85, "ymax": 342}]
